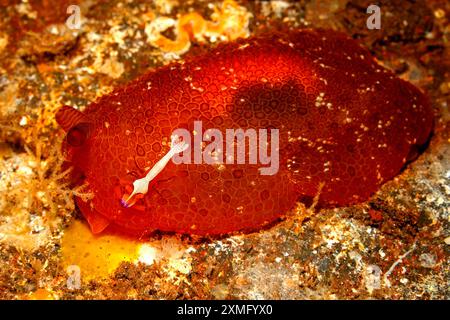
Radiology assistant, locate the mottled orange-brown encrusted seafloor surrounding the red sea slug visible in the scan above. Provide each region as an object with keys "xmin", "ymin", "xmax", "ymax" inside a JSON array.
[{"xmin": 0, "ymin": 0, "xmax": 450, "ymax": 299}]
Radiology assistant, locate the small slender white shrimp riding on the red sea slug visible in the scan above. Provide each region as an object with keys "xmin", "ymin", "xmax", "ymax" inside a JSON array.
[{"xmin": 122, "ymin": 136, "xmax": 189, "ymax": 208}]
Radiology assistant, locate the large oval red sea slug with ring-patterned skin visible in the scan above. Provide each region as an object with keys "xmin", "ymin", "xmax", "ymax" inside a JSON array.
[{"xmin": 56, "ymin": 30, "xmax": 433, "ymax": 235}]
